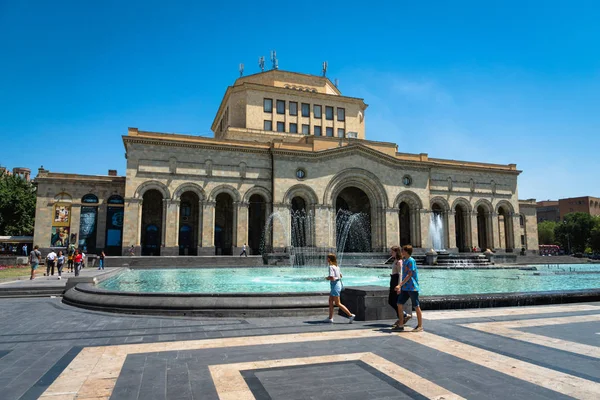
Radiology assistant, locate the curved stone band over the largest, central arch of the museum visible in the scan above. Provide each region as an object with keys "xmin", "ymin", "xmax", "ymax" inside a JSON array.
[{"xmin": 323, "ymin": 168, "xmax": 388, "ymax": 208}]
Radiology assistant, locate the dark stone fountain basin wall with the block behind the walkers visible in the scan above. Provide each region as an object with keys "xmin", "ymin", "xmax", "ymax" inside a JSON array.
[{"xmin": 63, "ymin": 283, "xmax": 600, "ymax": 321}]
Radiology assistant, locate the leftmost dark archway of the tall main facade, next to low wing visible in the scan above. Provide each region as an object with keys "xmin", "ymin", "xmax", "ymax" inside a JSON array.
[{"xmin": 141, "ymin": 189, "xmax": 163, "ymax": 256}]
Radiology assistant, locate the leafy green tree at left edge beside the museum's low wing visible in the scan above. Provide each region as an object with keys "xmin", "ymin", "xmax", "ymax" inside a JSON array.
[{"xmin": 0, "ymin": 174, "xmax": 36, "ymax": 236}]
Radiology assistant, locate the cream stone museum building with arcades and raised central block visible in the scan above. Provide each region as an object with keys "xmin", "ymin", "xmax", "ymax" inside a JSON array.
[{"xmin": 34, "ymin": 69, "xmax": 538, "ymax": 256}]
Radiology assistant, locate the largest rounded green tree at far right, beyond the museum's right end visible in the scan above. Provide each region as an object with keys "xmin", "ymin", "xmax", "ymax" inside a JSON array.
[{"xmin": 554, "ymin": 212, "xmax": 595, "ymax": 253}]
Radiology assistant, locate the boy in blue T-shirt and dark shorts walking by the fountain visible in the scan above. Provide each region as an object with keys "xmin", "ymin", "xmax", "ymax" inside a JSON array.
[{"xmin": 395, "ymin": 244, "xmax": 423, "ymax": 332}]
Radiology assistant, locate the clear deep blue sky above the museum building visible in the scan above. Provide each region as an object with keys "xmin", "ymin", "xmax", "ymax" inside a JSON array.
[{"xmin": 0, "ymin": 0, "xmax": 600, "ymax": 200}]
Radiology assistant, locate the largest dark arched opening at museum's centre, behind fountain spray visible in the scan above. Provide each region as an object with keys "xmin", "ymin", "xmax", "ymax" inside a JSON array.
[{"xmin": 335, "ymin": 186, "xmax": 372, "ymax": 253}]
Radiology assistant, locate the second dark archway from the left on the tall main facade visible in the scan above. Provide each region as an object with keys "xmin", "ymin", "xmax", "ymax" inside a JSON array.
[{"xmin": 178, "ymin": 192, "xmax": 200, "ymax": 256}]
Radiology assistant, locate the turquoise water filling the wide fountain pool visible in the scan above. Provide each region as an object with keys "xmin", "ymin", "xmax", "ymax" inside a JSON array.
[{"xmin": 98, "ymin": 264, "xmax": 600, "ymax": 295}]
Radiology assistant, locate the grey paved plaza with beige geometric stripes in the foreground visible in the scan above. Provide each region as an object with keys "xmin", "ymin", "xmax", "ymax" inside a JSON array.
[{"xmin": 0, "ymin": 298, "xmax": 600, "ymax": 400}]
